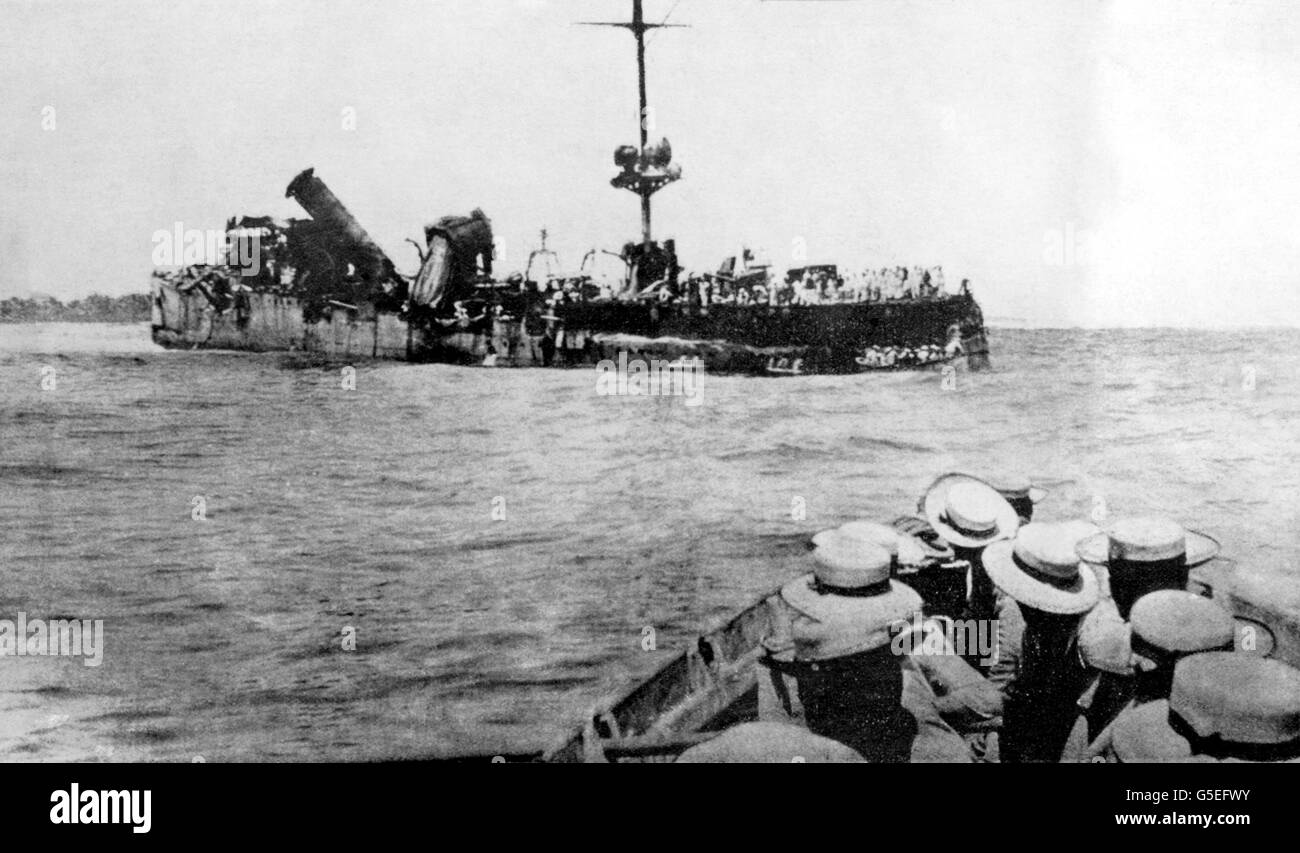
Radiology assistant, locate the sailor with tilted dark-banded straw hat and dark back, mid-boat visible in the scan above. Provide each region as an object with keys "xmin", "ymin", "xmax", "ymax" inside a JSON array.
[{"xmin": 983, "ymin": 523, "xmax": 1099, "ymax": 763}]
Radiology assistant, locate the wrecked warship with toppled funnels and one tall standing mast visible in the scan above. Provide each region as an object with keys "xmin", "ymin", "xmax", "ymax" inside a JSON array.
[{"xmin": 151, "ymin": 0, "xmax": 988, "ymax": 376}]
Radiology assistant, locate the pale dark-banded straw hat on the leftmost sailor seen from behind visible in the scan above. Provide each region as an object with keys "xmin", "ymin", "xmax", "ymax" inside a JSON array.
[{"xmin": 781, "ymin": 538, "xmax": 920, "ymax": 661}]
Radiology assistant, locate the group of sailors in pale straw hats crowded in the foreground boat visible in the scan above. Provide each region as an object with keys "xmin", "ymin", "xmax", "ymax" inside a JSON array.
[{"xmin": 679, "ymin": 473, "xmax": 1300, "ymax": 762}]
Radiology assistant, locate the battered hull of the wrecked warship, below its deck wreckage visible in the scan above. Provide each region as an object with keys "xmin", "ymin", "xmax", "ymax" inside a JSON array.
[{"xmin": 152, "ymin": 278, "xmax": 988, "ymax": 376}]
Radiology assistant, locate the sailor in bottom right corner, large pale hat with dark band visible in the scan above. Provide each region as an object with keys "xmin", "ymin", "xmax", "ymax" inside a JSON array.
[{"xmin": 1100, "ymin": 651, "xmax": 1300, "ymax": 763}]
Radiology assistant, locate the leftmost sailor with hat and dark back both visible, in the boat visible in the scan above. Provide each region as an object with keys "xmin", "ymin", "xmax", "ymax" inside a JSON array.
[{"xmin": 738, "ymin": 536, "xmax": 971, "ymax": 762}]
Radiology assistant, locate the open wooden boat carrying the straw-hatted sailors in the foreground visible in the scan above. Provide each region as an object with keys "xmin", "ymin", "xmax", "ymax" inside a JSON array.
[{"xmin": 542, "ymin": 560, "xmax": 1300, "ymax": 763}]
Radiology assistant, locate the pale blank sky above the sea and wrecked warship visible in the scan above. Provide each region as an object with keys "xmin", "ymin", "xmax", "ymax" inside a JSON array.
[{"xmin": 0, "ymin": 0, "xmax": 1300, "ymax": 326}]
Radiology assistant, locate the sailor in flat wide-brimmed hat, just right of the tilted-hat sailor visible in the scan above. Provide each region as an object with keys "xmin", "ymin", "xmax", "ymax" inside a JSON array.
[{"xmin": 1074, "ymin": 518, "xmax": 1218, "ymax": 748}]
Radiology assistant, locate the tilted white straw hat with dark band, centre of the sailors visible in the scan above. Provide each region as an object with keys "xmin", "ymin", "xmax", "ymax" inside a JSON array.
[{"xmin": 984, "ymin": 523, "xmax": 1097, "ymax": 615}]
